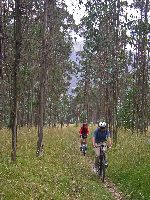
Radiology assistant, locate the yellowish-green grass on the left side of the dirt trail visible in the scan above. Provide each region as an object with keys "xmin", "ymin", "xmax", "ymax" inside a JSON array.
[{"xmin": 0, "ymin": 127, "xmax": 112, "ymax": 200}]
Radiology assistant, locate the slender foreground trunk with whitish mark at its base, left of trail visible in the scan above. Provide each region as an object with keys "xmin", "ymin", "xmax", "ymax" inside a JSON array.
[{"xmin": 36, "ymin": 0, "xmax": 48, "ymax": 156}]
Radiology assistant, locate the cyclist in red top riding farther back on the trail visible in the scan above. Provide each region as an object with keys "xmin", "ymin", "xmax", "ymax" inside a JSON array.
[{"xmin": 79, "ymin": 123, "xmax": 89, "ymax": 151}]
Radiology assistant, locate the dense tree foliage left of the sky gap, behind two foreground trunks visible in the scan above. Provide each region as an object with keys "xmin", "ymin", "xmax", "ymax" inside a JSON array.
[{"xmin": 2, "ymin": 0, "xmax": 76, "ymax": 126}]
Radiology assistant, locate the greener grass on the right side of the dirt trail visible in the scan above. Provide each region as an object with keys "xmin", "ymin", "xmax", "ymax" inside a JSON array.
[{"xmin": 107, "ymin": 131, "xmax": 150, "ymax": 200}]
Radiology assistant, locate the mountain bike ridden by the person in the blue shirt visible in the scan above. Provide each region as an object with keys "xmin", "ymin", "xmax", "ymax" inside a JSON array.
[{"xmin": 96, "ymin": 143, "xmax": 107, "ymax": 182}]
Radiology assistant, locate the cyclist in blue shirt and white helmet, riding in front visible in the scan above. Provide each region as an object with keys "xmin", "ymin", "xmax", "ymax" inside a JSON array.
[{"xmin": 92, "ymin": 122, "xmax": 112, "ymax": 169}]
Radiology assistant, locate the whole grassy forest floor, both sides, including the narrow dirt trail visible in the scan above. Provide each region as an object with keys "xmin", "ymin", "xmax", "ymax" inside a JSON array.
[{"xmin": 0, "ymin": 127, "xmax": 150, "ymax": 200}]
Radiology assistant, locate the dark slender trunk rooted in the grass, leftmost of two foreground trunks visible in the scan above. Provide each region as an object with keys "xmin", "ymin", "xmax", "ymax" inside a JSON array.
[{"xmin": 11, "ymin": 0, "xmax": 21, "ymax": 161}]
